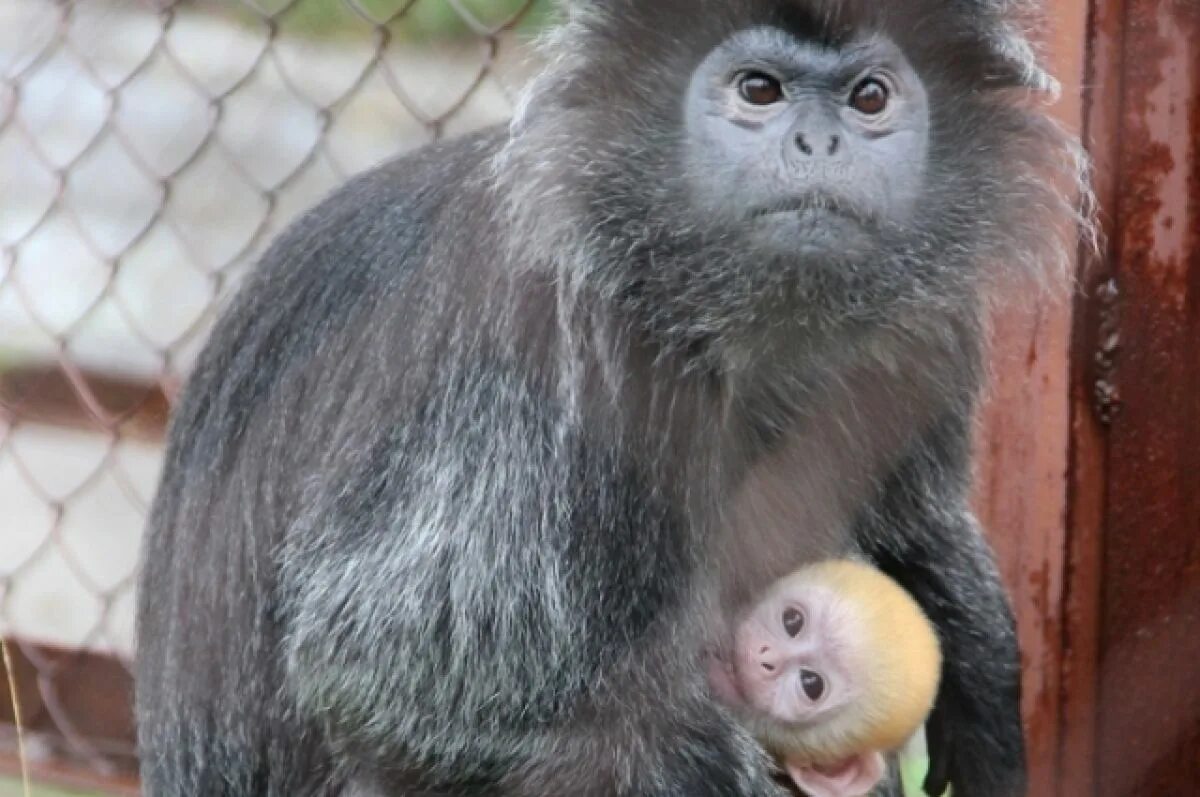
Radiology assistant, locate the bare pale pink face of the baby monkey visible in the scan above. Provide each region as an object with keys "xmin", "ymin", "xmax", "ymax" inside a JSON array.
[{"xmin": 730, "ymin": 580, "xmax": 860, "ymax": 724}]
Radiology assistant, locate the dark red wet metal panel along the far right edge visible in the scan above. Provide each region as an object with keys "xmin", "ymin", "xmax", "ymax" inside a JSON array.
[{"xmin": 1092, "ymin": 0, "xmax": 1200, "ymax": 797}]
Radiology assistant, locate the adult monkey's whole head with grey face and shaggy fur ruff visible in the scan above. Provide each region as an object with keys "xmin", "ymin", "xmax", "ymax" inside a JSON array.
[{"xmin": 499, "ymin": 0, "xmax": 1082, "ymax": 352}]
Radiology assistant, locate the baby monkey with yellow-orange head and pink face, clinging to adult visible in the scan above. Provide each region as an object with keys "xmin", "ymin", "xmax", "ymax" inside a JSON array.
[{"xmin": 709, "ymin": 559, "xmax": 942, "ymax": 797}]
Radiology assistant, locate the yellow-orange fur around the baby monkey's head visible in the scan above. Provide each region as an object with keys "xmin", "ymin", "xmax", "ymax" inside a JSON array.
[{"xmin": 745, "ymin": 559, "xmax": 942, "ymax": 766}]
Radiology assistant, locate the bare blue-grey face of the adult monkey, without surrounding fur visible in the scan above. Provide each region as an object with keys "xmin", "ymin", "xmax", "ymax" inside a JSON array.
[{"xmin": 684, "ymin": 28, "xmax": 930, "ymax": 258}]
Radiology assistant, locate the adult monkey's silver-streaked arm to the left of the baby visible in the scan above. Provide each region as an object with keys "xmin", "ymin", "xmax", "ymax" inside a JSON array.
[{"xmin": 281, "ymin": 350, "xmax": 772, "ymax": 797}]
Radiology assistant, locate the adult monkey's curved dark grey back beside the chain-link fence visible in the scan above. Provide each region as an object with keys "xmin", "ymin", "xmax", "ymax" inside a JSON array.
[{"xmin": 136, "ymin": 130, "xmax": 503, "ymax": 797}]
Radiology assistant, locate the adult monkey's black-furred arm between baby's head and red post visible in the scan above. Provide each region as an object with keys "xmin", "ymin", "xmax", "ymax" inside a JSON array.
[{"xmin": 858, "ymin": 413, "xmax": 1025, "ymax": 797}]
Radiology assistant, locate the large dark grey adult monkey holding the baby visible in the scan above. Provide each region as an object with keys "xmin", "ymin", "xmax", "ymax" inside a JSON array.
[{"xmin": 138, "ymin": 0, "xmax": 1076, "ymax": 797}]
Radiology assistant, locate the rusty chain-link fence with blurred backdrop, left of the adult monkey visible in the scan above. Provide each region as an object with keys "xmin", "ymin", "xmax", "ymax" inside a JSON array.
[{"xmin": 0, "ymin": 0, "xmax": 548, "ymax": 789}]
